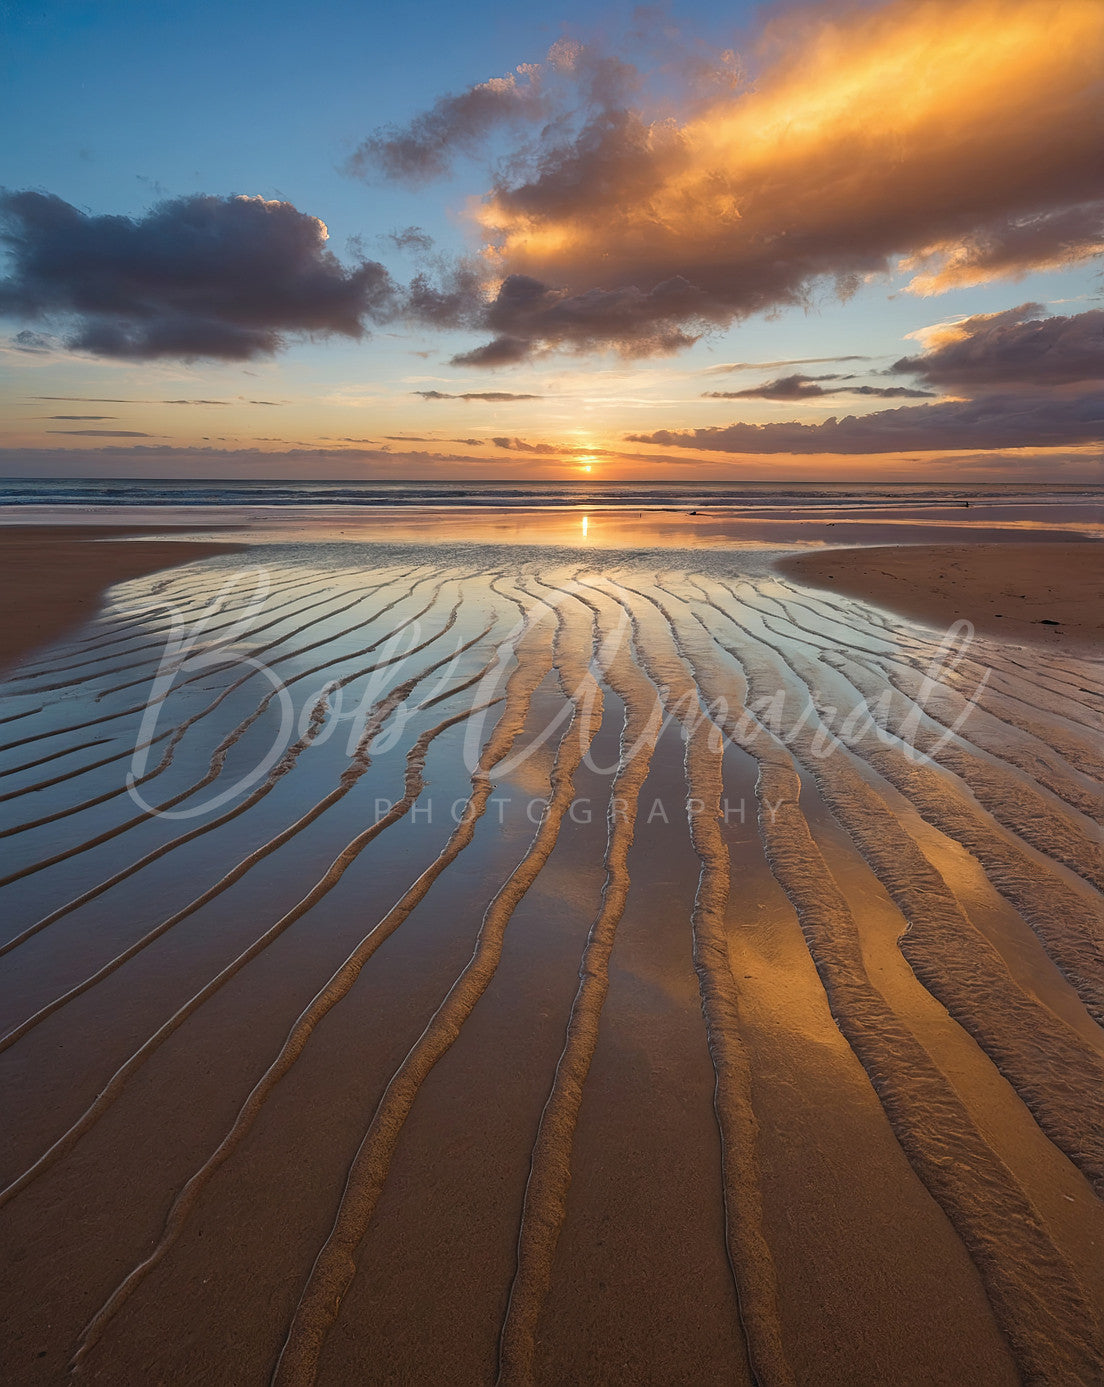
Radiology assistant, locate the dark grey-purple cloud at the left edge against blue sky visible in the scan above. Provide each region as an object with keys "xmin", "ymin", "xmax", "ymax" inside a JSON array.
[{"xmin": 0, "ymin": 191, "xmax": 395, "ymax": 361}]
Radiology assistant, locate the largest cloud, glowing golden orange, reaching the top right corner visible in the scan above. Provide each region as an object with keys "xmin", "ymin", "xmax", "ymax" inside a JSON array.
[{"xmin": 395, "ymin": 0, "xmax": 1104, "ymax": 366}]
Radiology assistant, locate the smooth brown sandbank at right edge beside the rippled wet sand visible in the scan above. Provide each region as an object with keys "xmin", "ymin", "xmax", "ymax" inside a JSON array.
[{"xmin": 774, "ymin": 540, "xmax": 1104, "ymax": 655}]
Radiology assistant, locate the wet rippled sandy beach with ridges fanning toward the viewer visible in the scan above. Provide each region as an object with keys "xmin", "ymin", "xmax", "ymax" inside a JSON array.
[{"xmin": 0, "ymin": 515, "xmax": 1104, "ymax": 1387}]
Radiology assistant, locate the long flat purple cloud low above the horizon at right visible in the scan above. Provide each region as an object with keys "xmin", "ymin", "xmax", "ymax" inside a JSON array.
[{"xmin": 627, "ymin": 390, "xmax": 1104, "ymax": 454}]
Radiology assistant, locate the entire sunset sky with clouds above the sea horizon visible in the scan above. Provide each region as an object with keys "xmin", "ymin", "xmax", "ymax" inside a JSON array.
[{"xmin": 0, "ymin": 0, "xmax": 1104, "ymax": 483}]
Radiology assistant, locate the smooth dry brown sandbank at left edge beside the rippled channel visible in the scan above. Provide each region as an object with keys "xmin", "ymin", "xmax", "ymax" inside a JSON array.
[{"xmin": 0, "ymin": 524, "xmax": 240, "ymax": 671}]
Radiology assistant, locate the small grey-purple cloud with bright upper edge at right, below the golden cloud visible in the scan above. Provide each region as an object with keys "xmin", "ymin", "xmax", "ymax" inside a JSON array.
[{"xmin": 892, "ymin": 304, "xmax": 1104, "ymax": 393}]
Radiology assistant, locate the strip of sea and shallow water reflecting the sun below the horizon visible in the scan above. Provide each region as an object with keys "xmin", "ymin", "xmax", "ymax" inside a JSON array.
[{"xmin": 0, "ymin": 479, "xmax": 1104, "ymax": 552}]
